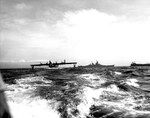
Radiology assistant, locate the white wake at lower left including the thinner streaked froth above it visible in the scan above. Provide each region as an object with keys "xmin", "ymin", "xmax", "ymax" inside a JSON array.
[{"xmin": 6, "ymin": 77, "xmax": 60, "ymax": 118}]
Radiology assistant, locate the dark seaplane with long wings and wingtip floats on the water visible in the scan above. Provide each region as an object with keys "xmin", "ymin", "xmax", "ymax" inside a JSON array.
[{"xmin": 30, "ymin": 60, "xmax": 77, "ymax": 70}]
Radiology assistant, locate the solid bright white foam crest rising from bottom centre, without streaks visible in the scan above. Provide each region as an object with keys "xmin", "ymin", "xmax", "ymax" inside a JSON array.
[{"xmin": 77, "ymin": 85, "xmax": 120, "ymax": 118}]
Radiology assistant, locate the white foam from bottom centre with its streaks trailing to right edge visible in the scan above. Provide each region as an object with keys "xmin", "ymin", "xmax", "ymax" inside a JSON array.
[{"xmin": 77, "ymin": 80, "xmax": 148, "ymax": 118}]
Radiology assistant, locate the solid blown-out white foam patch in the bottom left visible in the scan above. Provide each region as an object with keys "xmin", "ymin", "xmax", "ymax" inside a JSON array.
[{"xmin": 8, "ymin": 99, "xmax": 60, "ymax": 118}]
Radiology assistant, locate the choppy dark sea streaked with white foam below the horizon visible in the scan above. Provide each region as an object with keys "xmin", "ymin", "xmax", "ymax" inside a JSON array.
[{"xmin": 2, "ymin": 69, "xmax": 150, "ymax": 118}]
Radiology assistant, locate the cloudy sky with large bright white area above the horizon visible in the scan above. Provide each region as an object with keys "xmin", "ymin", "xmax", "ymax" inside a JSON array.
[{"xmin": 0, "ymin": 0, "xmax": 150, "ymax": 65}]
